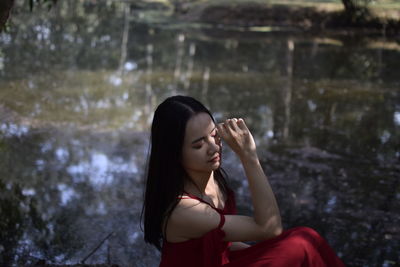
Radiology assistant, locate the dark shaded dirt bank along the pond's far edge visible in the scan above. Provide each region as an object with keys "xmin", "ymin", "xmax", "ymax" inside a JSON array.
[{"xmin": 175, "ymin": 3, "xmax": 400, "ymax": 36}]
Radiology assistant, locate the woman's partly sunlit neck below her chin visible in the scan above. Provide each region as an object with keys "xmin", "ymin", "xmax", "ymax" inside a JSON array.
[{"xmin": 185, "ymin": 171, "xmax": 216, "ymax": 195}]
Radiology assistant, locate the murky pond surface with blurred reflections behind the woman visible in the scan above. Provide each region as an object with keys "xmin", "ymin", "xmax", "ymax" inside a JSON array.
[{"xmin": 0, "ymin": 1, "xmax": 400, "ymax": 267}]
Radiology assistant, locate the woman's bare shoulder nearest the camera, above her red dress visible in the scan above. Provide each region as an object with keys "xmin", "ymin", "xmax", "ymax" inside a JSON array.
[{"xmin": 167, "ymin": 198, "xmax": 220, "ymax": 242}]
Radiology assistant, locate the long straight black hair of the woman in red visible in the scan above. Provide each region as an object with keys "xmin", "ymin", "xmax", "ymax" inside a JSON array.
[{"xmin": 141, "ymin": 95, "xmax": 229, "ymax": 250}]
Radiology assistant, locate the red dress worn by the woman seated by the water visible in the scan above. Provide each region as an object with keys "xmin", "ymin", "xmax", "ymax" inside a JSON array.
[{"xmin": 160, "ymin": 192, "xmax": 345, "ymax": 267}]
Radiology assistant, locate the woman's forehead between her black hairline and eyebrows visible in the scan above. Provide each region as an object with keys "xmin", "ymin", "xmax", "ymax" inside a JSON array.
[{"xmin": 185, "ymin": 112, "xmax": 215, "ymax": 141}]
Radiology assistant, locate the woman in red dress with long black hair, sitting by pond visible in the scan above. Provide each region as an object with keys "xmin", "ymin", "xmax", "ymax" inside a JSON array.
[{"xmin": 143, "ymin": 96, "xmax": 344, "ymax": 267}]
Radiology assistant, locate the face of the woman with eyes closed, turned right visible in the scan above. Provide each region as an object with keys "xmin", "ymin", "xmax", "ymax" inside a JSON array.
[{"xmin": 182, "ymin": 112, "xmax": 221, "ymax": 174}]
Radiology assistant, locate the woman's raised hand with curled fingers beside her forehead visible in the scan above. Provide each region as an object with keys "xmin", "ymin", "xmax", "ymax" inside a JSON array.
[{"xmin": 217, "ymin": 118, "xmax": 257, "ymax": 159}]
